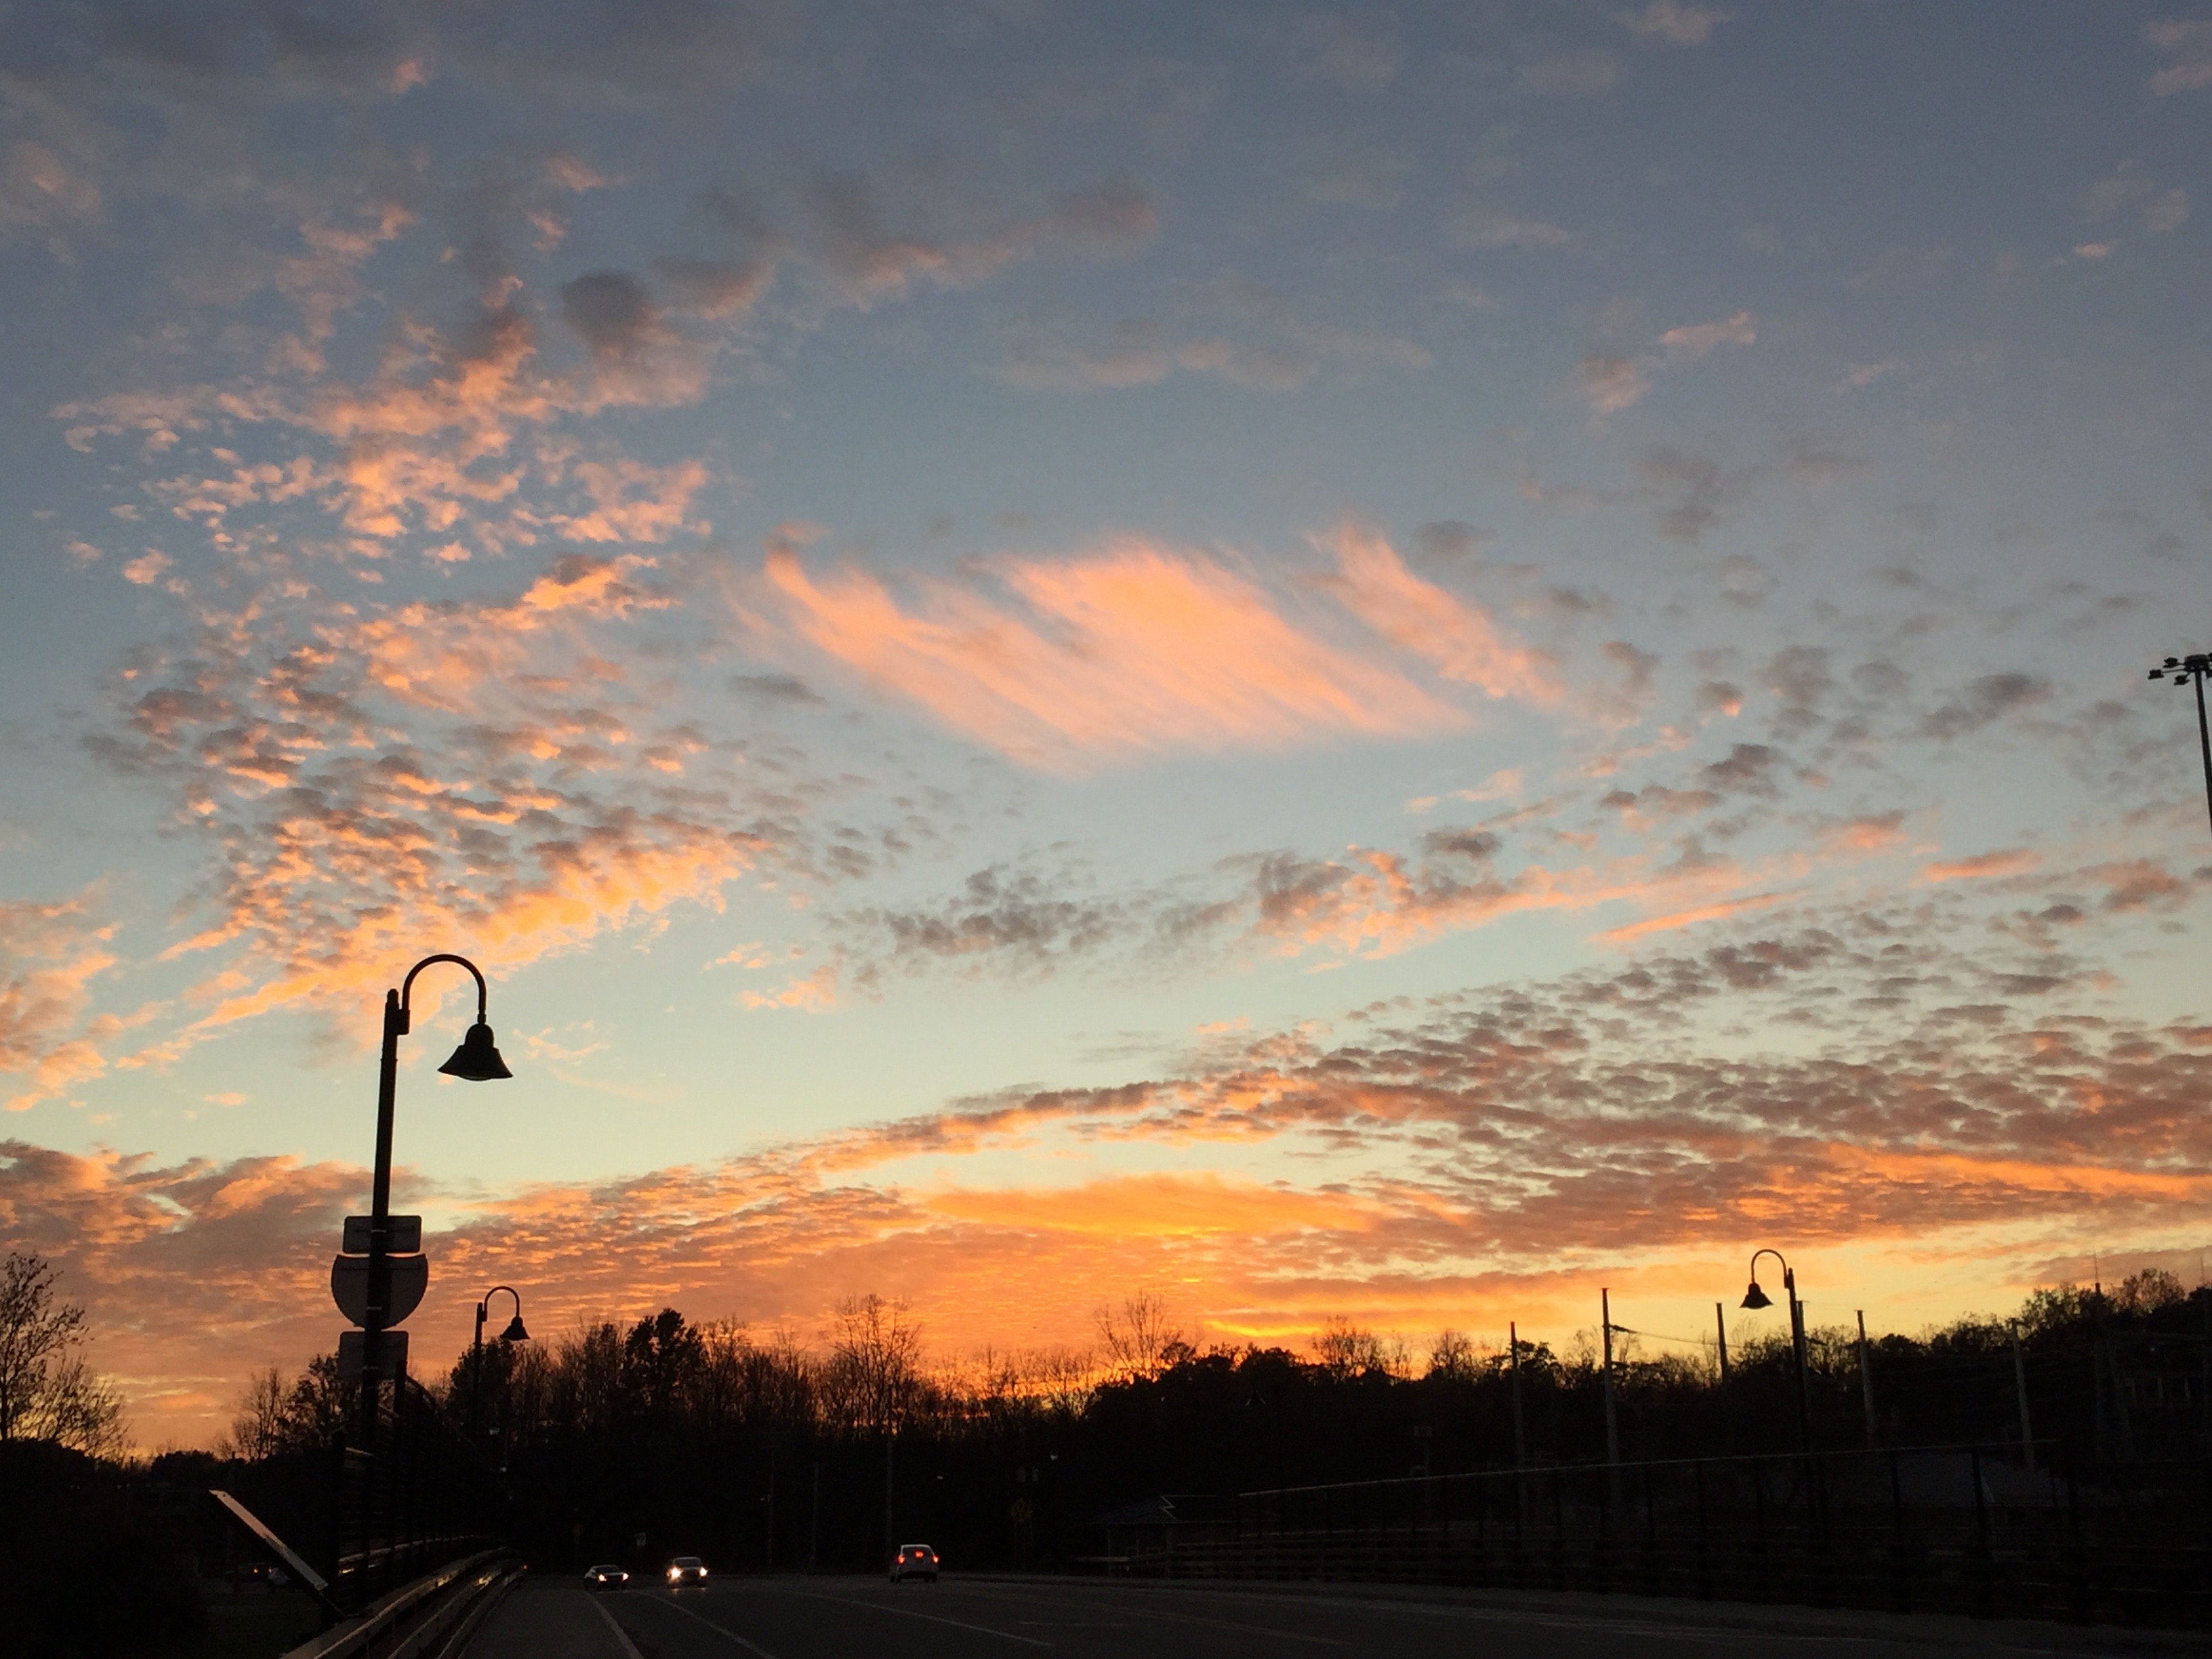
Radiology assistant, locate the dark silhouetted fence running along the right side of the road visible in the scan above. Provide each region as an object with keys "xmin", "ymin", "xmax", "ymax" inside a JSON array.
[{"xmin": 1090, "ymin": 1444, "xmax": 2212, "ymax": 1628}]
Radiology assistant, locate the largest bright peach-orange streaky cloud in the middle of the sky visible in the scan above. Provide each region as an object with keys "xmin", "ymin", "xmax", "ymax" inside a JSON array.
[{"xmin": 765, "ymin": 537, "xmax": 1465, "ymax": 772}]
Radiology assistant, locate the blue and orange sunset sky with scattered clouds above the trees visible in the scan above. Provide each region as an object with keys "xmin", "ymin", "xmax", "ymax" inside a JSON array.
[{"xmin": 0, "ymin": 0, "xmax": 2212, "ymax": 1447}]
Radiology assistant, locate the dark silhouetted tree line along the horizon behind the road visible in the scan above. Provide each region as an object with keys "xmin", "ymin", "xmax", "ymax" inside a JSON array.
[{"xmin": 203, "ymin": 1270, "xmax": 2212, "ymax": 1570}]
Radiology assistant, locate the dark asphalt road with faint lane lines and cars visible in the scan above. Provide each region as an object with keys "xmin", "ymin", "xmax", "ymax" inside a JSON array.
[{"xmin": 467, "ymin": 1577, "xmax": 2201, "ymax": 1659}]
